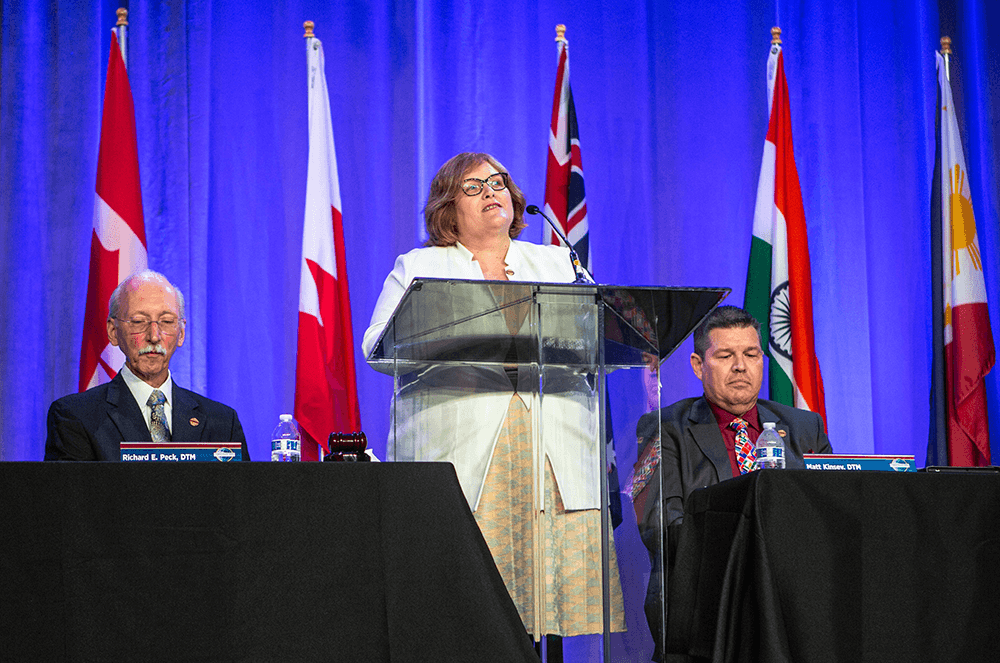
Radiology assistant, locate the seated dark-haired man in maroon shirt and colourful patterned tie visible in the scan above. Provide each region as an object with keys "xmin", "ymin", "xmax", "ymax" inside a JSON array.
[{"xmin": 631, "ymin": 306, "xmax": 833, "ymax": 660}]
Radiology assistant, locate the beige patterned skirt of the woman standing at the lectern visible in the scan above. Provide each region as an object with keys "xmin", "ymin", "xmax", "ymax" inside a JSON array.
[{"xmin": 475, "ymin": 394, "xmax": 625, "ymax": 637}]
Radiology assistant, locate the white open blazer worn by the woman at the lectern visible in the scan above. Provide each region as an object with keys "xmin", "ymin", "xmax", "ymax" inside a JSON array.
[{"xmin": 362, "ymin": 240, "xmax": 603, "ymax": 510}]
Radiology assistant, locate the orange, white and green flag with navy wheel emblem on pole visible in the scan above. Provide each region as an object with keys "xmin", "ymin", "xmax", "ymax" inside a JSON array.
[{"xmin": 744, "ymin": 35, "xmax": 826, "ymax": 422}]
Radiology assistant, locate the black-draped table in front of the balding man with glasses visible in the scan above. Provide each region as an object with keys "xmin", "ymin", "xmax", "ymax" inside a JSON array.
[{"xmin": 0, "ymin": 463, "xmax": 538, "ymax": 662}]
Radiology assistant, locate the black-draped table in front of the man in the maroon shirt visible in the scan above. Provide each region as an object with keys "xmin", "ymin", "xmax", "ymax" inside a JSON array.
[{"xmin": 667, "ymin": 470, "xmax": 1000, "ymax": 663}]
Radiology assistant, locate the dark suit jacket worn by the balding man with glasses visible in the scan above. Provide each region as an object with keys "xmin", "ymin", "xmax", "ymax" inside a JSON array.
[{"xmin": 45, "ymin": 373, "xmax": 250, "ymax": 460}]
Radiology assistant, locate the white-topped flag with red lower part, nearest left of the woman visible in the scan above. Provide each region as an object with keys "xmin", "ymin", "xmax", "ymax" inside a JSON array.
[{"xmin": 295, "ymin": 37, "xmax": 361, "ymax": 460}]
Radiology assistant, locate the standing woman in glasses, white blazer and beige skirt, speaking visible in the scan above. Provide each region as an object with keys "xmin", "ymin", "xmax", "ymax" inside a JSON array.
[{"xmin": 363, "ymin": 152, "xmax": 624, "ymax": 636}]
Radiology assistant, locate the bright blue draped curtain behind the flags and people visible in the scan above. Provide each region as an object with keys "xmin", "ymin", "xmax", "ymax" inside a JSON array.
[{"xmin": 0, "ymin": 0, "xmax": 1000, "ymax": 462}]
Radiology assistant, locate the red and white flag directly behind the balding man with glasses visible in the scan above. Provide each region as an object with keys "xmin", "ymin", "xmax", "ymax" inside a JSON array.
[{"xmin": 80, "ymin": 33, "xmax": 146, "ymax": 391}]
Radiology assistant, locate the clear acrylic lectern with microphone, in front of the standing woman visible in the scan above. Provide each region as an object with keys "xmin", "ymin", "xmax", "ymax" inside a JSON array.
[{"xmin": 368, "ymin": 279, "xmax": 729, "ymax": 661}]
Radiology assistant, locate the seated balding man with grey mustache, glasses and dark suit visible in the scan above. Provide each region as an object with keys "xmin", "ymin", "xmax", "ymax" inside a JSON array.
[{"xmin": 45, "ymin": 270, "xmax": 250, "ymax": 460}]
